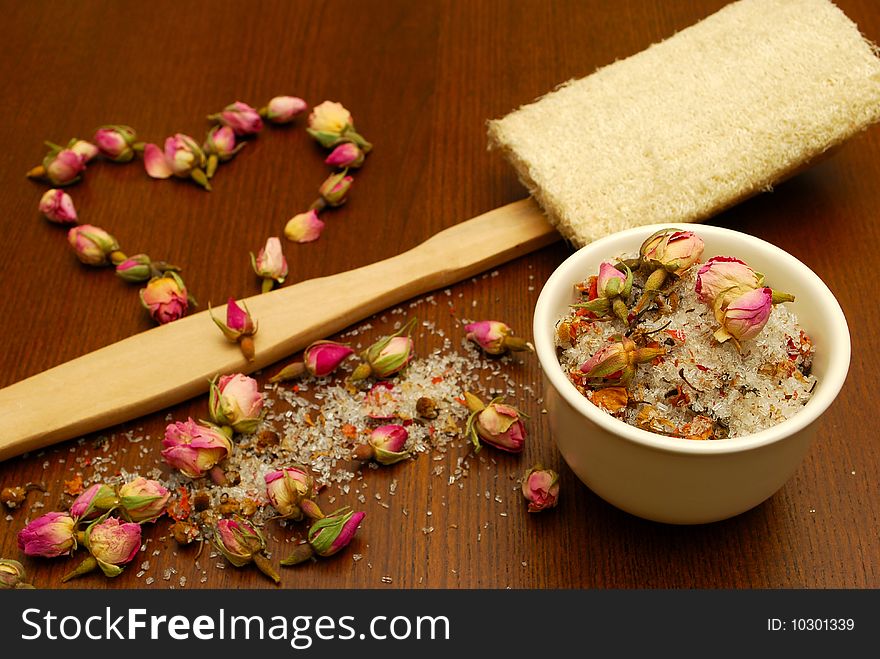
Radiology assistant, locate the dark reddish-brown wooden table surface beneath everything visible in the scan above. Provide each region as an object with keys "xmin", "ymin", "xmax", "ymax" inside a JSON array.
[{"xmin": 0, "ymin": 0, "xmax": 880, "ymax": 588}]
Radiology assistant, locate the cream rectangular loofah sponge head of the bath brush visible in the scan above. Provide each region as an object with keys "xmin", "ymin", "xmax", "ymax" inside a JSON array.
[{"xmin": 489, "ymin": 0, "xmax": 880, "ymax": 245}]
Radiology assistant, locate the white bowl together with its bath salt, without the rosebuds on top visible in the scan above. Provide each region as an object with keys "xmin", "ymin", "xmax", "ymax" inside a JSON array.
[{"xmin": 534, "ymin": 225, "xmax": 850, "ymax": 524}]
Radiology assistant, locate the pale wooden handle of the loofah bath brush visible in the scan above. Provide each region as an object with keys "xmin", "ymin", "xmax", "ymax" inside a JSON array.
[{"xmin": 0, "ymin": 199, "xmax": 559, "ymax": 460}]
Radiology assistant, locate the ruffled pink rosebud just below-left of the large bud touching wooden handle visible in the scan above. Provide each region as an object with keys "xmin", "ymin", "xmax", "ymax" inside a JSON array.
[{"xmin": 162, "ymin": 419, "xmax": 232, "ymax": 478}]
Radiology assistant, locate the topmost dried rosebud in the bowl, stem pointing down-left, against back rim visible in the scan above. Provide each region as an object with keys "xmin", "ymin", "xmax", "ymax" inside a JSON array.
[{"xmin": 633, "ymin": 229, "xmax": 704, "ymax": 314}]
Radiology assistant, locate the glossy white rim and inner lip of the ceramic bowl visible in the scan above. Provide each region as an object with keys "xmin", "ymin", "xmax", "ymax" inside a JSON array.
[{"xmin": 533, "ymin": 223, "xmax": 851, "ymax": 455}]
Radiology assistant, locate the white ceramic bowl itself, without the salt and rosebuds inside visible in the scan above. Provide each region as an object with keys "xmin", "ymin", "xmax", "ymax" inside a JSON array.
[{"xmin": 534, "ymin": 225, "xmax": 850, "ymax": 524}]
